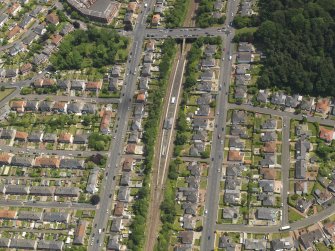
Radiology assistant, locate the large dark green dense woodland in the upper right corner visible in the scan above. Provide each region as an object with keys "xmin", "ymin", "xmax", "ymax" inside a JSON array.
[{"xmin": 254, "ymin": 0, "xmax": 335, "ymax": 96}]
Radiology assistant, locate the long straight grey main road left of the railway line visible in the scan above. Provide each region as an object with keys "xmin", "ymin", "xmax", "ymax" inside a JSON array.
[{"xmin": 88, "ymin": 0, "xmax": 154, "ymax": 251}]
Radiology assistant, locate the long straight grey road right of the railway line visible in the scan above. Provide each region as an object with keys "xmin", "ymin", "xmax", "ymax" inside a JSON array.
[{"xmin": 201, "ymin": 1, "xmax": 238, "ymax": 251}]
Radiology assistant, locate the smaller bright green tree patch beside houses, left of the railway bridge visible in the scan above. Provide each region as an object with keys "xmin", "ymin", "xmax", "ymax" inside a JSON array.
[{"xmin": 51, "ymin": 27, "xmax": 128, "ymax": 70}]
